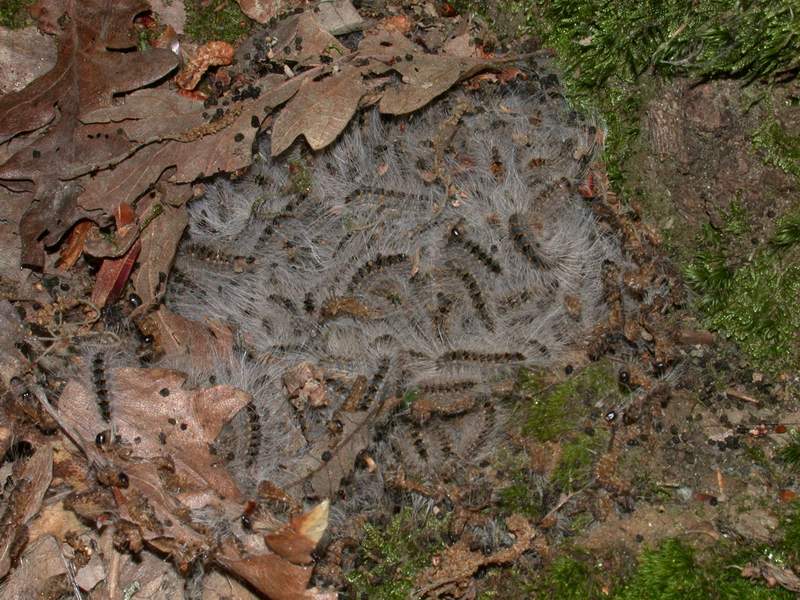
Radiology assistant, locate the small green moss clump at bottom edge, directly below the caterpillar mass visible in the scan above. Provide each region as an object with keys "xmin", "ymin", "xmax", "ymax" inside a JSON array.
[{"xmin": 347, "ymin": 507, "xmax": 447, "ymax": 600}]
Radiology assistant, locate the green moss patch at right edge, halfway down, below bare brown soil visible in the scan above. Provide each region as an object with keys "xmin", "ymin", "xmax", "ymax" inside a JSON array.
[{"xmin": 684, "ymin": 204, "xmax": 800, "ymax": 371}]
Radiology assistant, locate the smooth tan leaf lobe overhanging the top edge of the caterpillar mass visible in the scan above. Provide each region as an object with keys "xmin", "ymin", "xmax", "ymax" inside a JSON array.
[{"xmin": 272, "ymin": 65, "xmax": 366, "ymax": 156}]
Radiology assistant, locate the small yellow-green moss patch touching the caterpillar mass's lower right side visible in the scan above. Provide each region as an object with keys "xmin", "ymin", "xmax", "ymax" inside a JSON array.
[{"xmin": 521, "ymin": 361, "xmax": 620, "ymax": 442}]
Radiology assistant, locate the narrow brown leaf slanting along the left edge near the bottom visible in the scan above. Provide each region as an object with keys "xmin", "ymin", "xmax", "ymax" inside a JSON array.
[{"xmin": 0, "ymin": 444, "xmax": 53, "ymax": 577}]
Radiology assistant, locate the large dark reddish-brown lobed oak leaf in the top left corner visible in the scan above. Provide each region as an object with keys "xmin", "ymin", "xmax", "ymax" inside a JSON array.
[{"xmin": 0, "ymin": 0, "xmax": 177, "ymax": 267}]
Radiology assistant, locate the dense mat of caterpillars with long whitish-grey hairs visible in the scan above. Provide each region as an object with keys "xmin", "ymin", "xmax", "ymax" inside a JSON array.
[{"xmin": 142, "ymin": 74, "xmax": 636, "ymax": 522}]
